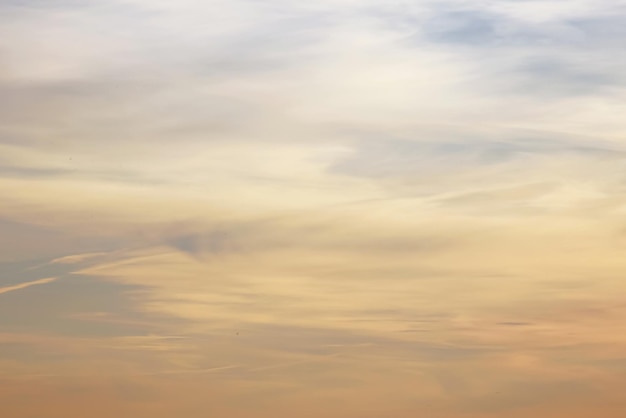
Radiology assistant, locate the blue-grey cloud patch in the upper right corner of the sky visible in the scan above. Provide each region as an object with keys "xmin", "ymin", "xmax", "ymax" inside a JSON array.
[{"xmin": 391, "ymin": 4, "xmax": 626, "ymax": 99}]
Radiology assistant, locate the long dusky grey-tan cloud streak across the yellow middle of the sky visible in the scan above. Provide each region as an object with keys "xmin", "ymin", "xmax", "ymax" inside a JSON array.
[{"xmin": 151, "ymin": 212, "xmax": 465, "ymax": 262}]
